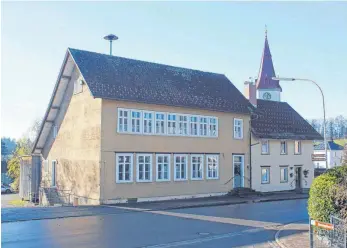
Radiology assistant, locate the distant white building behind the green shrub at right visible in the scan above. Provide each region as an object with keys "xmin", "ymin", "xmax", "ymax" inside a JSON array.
[{"xmin": 313, "ymin": 140, "xmax": 343, "ymax": 169}]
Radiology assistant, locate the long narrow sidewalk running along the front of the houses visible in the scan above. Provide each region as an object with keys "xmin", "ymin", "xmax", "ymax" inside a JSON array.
[{"xmin": 1, "ymin": 193, "xmax": 308, "ymax": 223}]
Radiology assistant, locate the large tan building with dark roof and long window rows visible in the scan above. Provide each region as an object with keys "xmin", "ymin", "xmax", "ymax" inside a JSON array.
[{"xmin": 33, "ymin": 48, "xmax": 252, "ymax": 204}]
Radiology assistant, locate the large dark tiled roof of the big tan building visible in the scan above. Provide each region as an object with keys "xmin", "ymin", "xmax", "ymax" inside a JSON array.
[{"xmin": 69, "ymin": 48, "xmax": 251, "ymax": 113}]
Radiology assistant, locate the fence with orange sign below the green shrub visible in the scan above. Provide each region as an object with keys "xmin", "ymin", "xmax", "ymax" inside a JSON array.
[{"xmin": 310, "ymin": 216, "xmax": 347, "ymax": 248}]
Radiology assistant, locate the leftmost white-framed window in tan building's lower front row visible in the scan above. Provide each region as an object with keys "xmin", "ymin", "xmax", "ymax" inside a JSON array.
[{"xmin": 116, "ymin": 153, "xmax": 133, "ymax": 183}]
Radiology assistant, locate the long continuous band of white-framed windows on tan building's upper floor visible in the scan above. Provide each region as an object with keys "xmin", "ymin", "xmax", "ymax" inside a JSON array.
[{"xmin": 117, "ymin": 108, "xmax": 218, "ymax": 137}]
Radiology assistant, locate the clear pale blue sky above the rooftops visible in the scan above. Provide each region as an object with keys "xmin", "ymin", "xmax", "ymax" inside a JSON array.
[{"xmin": 1, "ymin": 1, "xmax": 347, "ymax": 138}]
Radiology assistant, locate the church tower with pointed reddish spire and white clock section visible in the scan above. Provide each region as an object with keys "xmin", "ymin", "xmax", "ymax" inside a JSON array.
[{"xmin": 256, "ymin": 30, "xmax": 282, "ymax": 102}]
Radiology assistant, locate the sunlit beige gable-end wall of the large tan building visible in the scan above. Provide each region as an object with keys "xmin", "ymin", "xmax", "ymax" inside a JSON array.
[{"xmin": 42, "ymin": 68, "xmax": 101, "ymax": 204}]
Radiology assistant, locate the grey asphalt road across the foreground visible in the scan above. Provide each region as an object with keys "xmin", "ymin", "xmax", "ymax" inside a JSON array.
[{"xmin": 1, "ymin": 200, "xmax": 308, "ymax": 248}]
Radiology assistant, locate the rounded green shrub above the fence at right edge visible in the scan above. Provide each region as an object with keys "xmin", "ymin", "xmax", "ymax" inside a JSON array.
[{"xmin": 308, "ymin": 166, "xmax": 347, "ymax": 222}]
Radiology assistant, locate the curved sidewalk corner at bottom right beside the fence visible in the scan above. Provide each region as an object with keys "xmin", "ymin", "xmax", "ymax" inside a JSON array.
[{"xmin": 276, "ymin": 221, "xmax": 310, "ymax": 248}]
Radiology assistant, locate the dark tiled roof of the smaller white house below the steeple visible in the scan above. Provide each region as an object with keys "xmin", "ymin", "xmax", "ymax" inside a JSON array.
[{"xmin": 252, "ymin": 100, "xmax": 323, "ymax": 140}]
